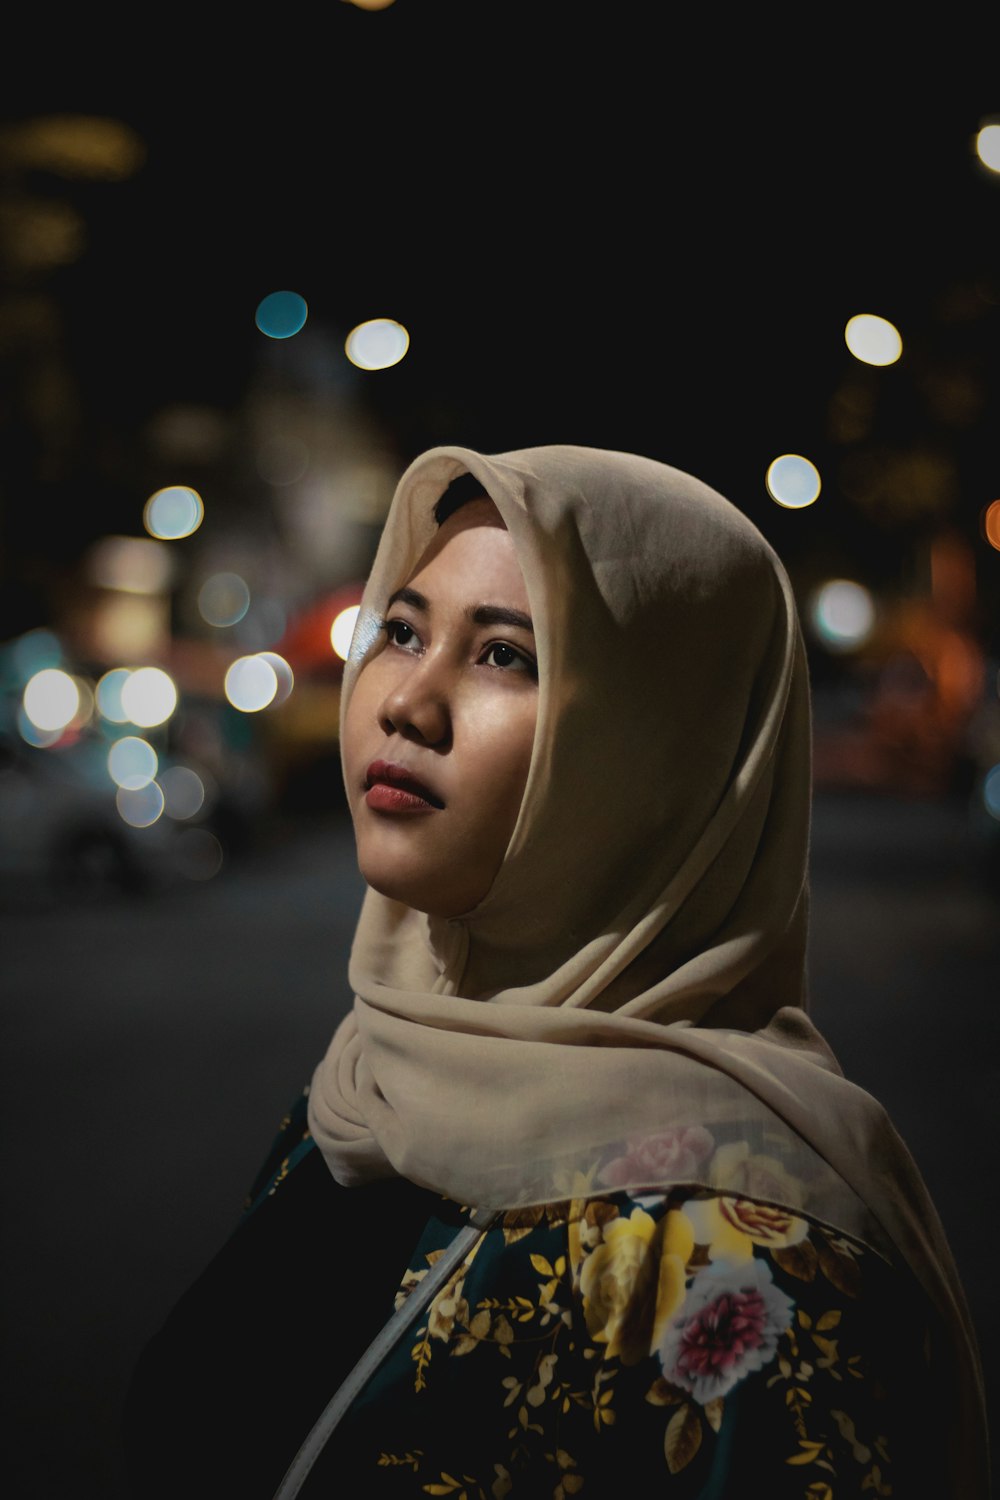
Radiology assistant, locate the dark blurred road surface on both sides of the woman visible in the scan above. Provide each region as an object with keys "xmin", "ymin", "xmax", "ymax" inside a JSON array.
[{"xmin": 0, "ymin": 794, "xmax": 1000, "ymax": 1500}]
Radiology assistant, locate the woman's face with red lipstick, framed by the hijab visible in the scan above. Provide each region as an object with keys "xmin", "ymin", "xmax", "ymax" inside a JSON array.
[{"xmin": 342, "ymin": 498, "xmax": 538, "ymax": 917}]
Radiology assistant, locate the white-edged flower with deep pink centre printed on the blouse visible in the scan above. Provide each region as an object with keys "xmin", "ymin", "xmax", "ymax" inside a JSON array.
[{"xmin": 657, "ymin": 1260, "xmax": 795, "ymax": 1406}]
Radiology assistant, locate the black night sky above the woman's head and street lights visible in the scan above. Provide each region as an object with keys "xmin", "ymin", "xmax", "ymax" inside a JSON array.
[{"xmin": 3, "ymin": 0, "xmax": 1000, "ymax": 645}]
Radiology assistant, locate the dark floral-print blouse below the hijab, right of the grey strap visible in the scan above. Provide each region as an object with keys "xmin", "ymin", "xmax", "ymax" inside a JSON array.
[{"xmin": 242, "ymin": 1098, "xmax": 939, "ymax": 1500}]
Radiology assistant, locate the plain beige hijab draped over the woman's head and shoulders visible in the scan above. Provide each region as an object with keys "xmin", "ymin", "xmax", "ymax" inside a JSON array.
[{"xmin": 309, "ymin": 447, "xmax": 985, "ymax": 1496}]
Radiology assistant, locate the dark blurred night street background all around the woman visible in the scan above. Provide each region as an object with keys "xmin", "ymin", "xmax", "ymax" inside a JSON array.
[{"xmin": 0, "ymin": 0, "xmax": 1000, "ymax": 1500}]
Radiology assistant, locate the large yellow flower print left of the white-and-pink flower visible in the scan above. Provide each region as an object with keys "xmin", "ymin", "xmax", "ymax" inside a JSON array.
[{"xmin": 580, "ymin": 1209, "xmax": 694, "ymax": 1365}]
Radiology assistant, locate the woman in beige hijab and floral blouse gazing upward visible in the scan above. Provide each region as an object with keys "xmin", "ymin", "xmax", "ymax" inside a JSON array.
[{"xmin": 122, "ymin": 447, "xmax": 987, "ymax": 1500}]
